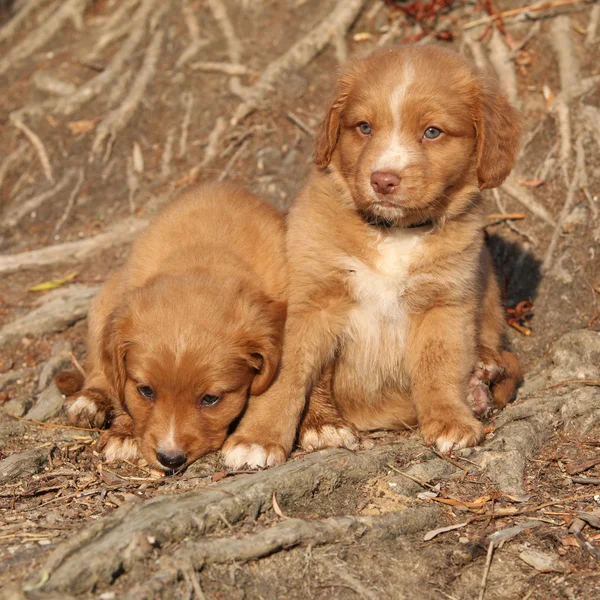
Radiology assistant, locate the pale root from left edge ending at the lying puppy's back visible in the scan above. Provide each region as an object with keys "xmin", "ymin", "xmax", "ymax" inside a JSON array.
[{"xmin": 0, "ymin": 218, "xmax": 148, "ymax": 273}]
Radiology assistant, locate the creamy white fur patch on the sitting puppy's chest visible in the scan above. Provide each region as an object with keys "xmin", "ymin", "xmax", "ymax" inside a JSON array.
[{"xmin": 342, "ymin": 229, "xmax": 423, "ymax": 383}]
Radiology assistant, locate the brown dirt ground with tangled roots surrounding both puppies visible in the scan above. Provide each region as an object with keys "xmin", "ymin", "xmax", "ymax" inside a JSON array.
[{"xmin": 0, "ymin": 0, "xmax": 600, "ymax": 600}]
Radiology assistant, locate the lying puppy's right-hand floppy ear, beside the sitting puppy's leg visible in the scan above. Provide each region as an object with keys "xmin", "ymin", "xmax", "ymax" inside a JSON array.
[{"xmin": 240, "ymin": 290, "xmax": 287, "ymax": 396}]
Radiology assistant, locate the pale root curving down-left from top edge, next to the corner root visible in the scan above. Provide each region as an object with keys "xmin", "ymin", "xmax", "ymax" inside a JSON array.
[{"xmin": 54, "ymin": 0, "xmax": 158, "ymax": 115}]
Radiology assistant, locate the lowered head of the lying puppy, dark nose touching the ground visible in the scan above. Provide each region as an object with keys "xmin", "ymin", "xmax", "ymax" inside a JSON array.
[{"xmin": 105, "ymin": 276, "xmax": 285, "ymax": 470}]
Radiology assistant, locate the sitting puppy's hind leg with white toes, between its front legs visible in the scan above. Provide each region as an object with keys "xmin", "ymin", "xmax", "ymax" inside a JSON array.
[{"xmin": 298, "ymin": 365, "xmax": 358, "ymax": 452}]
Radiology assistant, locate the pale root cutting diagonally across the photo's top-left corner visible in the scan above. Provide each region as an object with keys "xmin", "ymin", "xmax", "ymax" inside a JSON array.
[{"xmin": 0, "ymin": 0, "xmax": 89, "ymax": 75}]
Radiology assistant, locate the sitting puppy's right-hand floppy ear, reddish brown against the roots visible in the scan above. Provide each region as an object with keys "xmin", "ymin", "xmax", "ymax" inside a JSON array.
[{"xmin": 475, "ymin": 74, "xmax": 521, "ymax": 190}]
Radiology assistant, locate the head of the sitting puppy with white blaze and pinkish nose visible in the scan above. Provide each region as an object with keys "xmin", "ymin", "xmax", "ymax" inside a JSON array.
[{"xmin": 315, "ymin": 46, "xmax": 520, "ymax": 225}]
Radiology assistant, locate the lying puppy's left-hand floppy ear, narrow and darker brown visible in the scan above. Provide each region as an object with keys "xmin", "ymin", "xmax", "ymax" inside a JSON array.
[{"xmin": 102, "ymin": 307, "xmax": 129, "ymax": 402}]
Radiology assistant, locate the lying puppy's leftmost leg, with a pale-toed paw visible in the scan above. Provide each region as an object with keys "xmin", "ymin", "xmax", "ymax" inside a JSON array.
[{"xmin": 66, "ymin": 275, "xmax": 119, "ymax": 427}]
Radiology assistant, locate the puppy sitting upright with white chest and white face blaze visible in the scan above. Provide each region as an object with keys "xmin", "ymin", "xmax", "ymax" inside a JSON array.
[{"xmin": 223, "ymin": 46, "xmax": 520, "ymax": 467}]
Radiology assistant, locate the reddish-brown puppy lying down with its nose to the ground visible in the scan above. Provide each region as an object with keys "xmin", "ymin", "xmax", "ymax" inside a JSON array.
[{"xmin": 57, "ymin": 184, "xmax": 286, "ymax": 470}]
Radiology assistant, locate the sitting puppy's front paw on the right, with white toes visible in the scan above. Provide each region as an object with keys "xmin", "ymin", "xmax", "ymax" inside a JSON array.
[{"xmin": 421, "ymin": 408, "xmax": 485, "ymax": 453}]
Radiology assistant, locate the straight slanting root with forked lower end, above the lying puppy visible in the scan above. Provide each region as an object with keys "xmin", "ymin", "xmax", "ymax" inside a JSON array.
[{"xmin": 90, "ymin": 30, "xmax": 164, "ymax": 162}]
